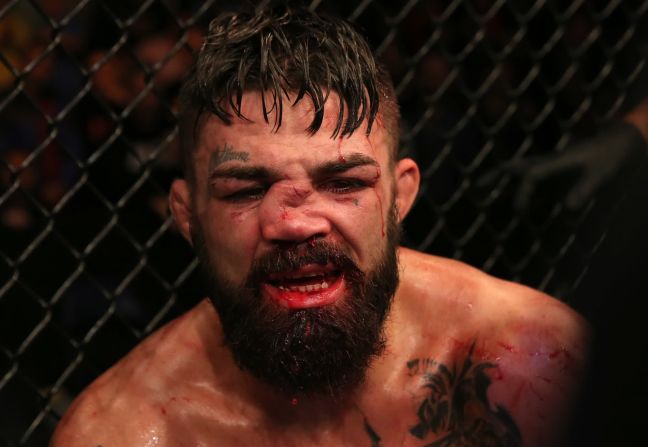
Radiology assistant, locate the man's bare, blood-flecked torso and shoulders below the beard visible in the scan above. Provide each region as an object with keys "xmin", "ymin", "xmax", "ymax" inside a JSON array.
[{"xmin": 52, "ymin": 249, "xmax": 587, "ymax": 447}]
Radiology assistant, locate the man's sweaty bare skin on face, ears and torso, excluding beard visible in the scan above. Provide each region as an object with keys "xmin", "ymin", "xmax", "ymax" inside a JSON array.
[{"xmin": 51, "ymin": 94, "xmax": 587, "ymax": 447}]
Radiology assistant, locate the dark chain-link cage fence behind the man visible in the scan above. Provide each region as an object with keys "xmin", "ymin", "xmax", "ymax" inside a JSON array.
[{"xmin": 0, "ymin": 0, "xmax": 648, "ymax": 445}]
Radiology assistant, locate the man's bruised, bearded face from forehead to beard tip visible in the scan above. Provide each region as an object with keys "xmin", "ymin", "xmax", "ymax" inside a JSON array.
[{"xmin": 175, "ymin": 93, "xmax": 416, "ymax": 393}]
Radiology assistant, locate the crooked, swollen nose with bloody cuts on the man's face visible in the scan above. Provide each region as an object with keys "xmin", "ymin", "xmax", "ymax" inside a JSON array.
[{"xmin": 259, "ymin": 186, "xmax": 331, "ymax": 242}]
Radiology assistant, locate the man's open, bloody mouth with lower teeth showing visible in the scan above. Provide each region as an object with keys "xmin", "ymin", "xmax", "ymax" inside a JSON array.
[{"xmin": 263, "ymin": 265, "xmax": 344, "ymax": 308}]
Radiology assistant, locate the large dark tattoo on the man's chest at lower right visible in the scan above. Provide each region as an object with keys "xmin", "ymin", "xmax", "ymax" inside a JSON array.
[{"xmin": 406, "ymin": 341, "xmax": 522, "ymax": 447}]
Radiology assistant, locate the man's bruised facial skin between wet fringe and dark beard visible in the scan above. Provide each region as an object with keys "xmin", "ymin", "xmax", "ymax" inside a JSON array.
[{"xmin": 186, "ymin": 97, "xmax": 405, "ymax": 300}]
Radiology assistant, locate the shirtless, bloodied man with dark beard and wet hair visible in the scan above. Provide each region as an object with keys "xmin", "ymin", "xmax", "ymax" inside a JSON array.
[{"xmin": 52, "ymin": 7, "xmax": 587, "ymax": 447}]
